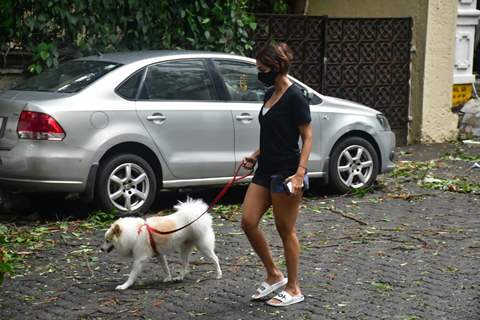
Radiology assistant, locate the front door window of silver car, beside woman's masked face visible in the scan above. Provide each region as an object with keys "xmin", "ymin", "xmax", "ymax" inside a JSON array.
[{"xmin": 214, "ymin": 60, "xmax": 265, "ymax": 102}]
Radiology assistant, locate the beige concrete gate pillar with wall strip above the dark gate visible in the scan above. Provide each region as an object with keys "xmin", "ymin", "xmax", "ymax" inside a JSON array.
[{"xmin": 308, "ymin": 0, "xmax": 457, "ymax": 143}]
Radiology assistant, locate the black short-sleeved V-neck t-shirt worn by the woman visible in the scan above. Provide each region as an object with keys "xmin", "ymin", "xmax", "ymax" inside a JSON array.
[{"xmin": 258, "ymin": 84, "xmax": 312, "ymax": 174}]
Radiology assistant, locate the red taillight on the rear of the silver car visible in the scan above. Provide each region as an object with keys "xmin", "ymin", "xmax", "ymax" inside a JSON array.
[{"xmin": 17, "ymin": 111, "xmax": 65, "ymax": 141}]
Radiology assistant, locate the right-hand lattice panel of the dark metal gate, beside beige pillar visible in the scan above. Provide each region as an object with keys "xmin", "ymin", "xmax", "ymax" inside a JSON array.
[{"xmin": 323, "ymin": 18, "xmax": 412, "ymax": 144}]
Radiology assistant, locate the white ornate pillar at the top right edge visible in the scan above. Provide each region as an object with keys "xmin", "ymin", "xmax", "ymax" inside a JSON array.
[{"xmin": 453, "ymin": 0, "xmax": 480, "ymax": 84}]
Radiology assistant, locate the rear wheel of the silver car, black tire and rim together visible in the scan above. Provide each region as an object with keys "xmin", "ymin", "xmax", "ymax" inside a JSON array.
[{"xmin": 95, "ymin": 154, "xmax": 157, "ymax": 216}]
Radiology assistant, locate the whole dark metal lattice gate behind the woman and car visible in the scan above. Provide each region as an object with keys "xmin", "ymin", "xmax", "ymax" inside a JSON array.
[{"xmin": 255, "ymin": 14, "xmax": 412, "ymax": 145}]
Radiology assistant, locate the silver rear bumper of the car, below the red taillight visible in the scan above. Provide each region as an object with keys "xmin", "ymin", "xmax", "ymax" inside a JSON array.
[{"xmin": 0, "ymin": 141, "xmax": 93, "ymax": 193}]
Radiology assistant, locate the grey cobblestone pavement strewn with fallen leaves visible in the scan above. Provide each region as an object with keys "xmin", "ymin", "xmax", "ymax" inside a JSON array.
[{"xmin": 0, "ymin": 144, "xmax": 480, "ymax": 320}]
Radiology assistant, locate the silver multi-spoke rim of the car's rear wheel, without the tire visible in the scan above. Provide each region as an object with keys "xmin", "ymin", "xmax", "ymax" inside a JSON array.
[{"xmin": 108, "ymin": 163, "xmax": 150, "ymax": 212}]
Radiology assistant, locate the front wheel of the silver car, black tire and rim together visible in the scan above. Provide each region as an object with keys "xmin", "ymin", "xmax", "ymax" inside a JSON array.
[{"xmin": 329, "ymin": 137, "xmax": 379, "ymax": 193}]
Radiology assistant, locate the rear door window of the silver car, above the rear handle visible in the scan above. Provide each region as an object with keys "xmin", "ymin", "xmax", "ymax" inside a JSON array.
[{"xmin": 140, "ymin": 60, "xmax": 215, "ymax": 100}]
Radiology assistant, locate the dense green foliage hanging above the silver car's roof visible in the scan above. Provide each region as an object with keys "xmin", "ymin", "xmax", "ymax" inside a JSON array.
[{"xmin": 0, "ymin": 0, "xmax": 256, "ymax": 73}]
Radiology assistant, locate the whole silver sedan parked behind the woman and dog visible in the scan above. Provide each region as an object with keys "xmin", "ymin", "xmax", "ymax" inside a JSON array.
[{"xmin": 0, "ymin": 51, "xmax": 395, "ymax": 214}]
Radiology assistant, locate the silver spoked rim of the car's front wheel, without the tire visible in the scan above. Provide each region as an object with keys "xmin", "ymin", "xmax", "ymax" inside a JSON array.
[{"xmin": 337, "ymin": 145, "xmax": 373, "ymax": 188}]
